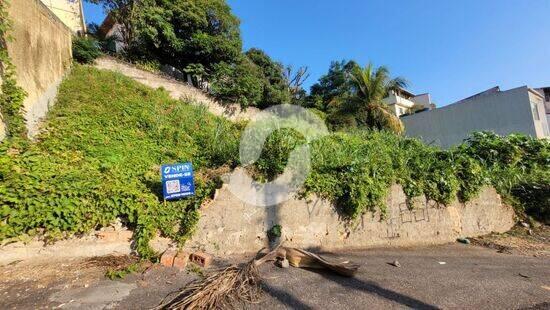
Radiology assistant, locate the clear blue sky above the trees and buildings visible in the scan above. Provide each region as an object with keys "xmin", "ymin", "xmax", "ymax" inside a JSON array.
[{"xmin": 85, "ymin": 0, "xmax": 550, "ymax": 106}]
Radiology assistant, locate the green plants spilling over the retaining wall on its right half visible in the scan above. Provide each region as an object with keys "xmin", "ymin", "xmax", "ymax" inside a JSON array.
[{"xmin": 262, "ymin": 130, "xmax": 550, "ymax": 221}]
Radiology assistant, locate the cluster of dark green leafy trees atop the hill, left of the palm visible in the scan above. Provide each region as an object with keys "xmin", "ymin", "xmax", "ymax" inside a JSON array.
[{"xmin": 90, "ymin": 0, "xmax": 305, "ymax": 108}]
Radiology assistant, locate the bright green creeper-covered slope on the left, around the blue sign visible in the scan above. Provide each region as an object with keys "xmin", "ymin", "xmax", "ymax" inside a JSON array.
[{"xmin": 0, "ymin": 65, "xmax": 239, "ymax": 257}]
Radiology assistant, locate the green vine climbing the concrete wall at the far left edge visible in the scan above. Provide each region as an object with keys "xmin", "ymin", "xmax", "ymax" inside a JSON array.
[{"xmin": 0, "ymin": 0, "xmax": 27, "ymax": 137}]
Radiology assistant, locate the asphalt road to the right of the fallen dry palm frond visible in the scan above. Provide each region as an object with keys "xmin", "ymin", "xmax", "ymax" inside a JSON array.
[{"xmin": 254, "ymin": 244, "xmax": 550, "ymax": 309}]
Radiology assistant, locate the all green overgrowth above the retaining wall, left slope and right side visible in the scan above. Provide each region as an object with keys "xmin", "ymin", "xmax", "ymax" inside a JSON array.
[{"xmin": 0, "ymin": 65, "xmax": 550, "ymax": 257}]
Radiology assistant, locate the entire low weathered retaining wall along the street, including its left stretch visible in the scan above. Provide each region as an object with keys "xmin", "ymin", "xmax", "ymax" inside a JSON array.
[{"xmin": 0, "ymin": 186, "xmax": 515, "ymax": 265}]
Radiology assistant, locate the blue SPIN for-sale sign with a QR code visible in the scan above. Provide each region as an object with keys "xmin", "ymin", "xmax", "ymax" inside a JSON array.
[{"xmin": 160, "ymin": 163, "xmax": 195, "ymax": 200}]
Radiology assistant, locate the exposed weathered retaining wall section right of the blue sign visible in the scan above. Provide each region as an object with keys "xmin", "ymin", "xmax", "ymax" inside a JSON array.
[{"xmin": 188, "ymin": 186, "xmax": 515, "ymax": 254}]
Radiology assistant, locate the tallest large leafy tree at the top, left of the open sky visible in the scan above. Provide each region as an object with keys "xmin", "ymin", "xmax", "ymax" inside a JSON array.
[{"xmin": 133, "ymin": 0, "xmax": 242, "ymax": 71}]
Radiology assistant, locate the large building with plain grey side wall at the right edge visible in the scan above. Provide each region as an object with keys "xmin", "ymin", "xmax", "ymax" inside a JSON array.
[{"xmin": 401, "ymin": 86, "xmax": 549, "ymax": 147}]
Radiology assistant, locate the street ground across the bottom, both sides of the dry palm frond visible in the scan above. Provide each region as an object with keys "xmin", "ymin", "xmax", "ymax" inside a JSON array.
[{"xmin": 0, "ymin": 244, "xmax": 550, "ymax": 309}]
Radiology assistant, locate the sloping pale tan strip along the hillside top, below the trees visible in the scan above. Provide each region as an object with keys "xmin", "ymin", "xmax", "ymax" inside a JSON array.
[{"xmin": 95, "ymin": 57, "xmax": 259, "ymax": 121}]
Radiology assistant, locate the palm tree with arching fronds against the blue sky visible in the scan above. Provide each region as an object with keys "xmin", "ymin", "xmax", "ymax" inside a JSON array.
[{"xmin": 344, "ymin": 63, "xmax": 407, "ymax": 134}]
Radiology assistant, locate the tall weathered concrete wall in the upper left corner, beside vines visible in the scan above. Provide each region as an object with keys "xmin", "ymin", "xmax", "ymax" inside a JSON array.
[{"xmin": 8, "ymin": 0, "xmax": 72, "ymax": 137}]
